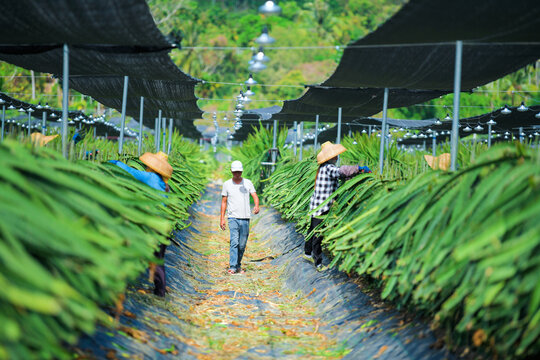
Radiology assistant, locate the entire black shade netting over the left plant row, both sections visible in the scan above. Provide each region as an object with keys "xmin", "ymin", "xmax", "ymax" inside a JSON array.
[{"xmin": 0, "ymin": 0, "xmax": 202, "ymax": 136}]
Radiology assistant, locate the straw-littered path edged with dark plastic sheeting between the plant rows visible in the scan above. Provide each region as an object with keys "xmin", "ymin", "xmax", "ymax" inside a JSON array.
[{"xmin": 77, "ymin": 184, "xmax": 454, "ymax": 359}]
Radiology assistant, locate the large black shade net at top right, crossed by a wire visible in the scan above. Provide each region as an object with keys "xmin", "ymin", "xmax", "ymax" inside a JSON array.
[{"xmin": 322, "ymin": 0, "xmax": 540, "ymax": 90}]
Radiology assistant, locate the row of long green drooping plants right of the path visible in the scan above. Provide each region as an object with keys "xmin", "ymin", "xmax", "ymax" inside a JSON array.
[{"xmin": 264, "ymin": 139, "xmax": 540, "ymax": 358}]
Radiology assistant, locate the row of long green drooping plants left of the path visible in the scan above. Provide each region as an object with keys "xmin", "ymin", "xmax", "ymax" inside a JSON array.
[{"xmin": 0, "ymin": 136, "xmax": 207, "ymax": 359}]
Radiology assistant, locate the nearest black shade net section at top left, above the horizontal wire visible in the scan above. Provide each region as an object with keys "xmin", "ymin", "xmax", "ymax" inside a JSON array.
[{"xmin": 0, "ymin": 0, "xmax": 170, "ymax": 47}]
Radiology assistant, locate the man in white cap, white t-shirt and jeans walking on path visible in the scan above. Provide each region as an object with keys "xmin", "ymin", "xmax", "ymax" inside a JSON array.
[{"xmin": 220, "ymin": 160, "xmax": 259, "ymax": 274}]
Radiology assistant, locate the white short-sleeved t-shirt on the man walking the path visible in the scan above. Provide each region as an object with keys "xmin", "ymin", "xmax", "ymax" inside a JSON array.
[{"xmin": 221, "ymin": 179, "xmax": 255, "ymax": 219}]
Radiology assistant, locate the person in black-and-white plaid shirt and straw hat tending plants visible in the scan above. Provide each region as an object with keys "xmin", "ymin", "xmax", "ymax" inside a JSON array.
[{"xmin": 304, "ymin": 141, "xmax": 371, "ymax": 270}]
